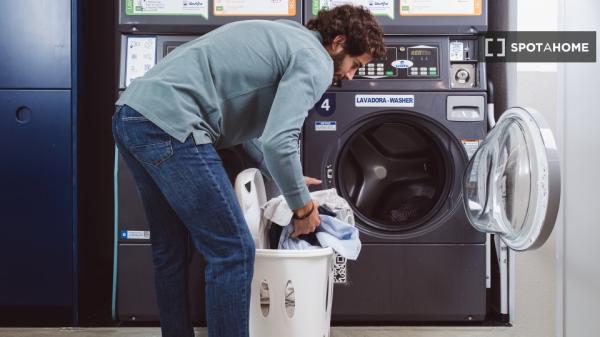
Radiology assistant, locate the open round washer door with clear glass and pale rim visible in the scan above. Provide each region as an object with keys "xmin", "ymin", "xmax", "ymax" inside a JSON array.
[{"xmin": 463, "ymin": 107, "xmax": 560, "ymax": 251}]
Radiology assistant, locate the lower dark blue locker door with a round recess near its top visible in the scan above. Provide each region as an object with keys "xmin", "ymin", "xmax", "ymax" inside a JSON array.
[{"xmin": 0, "ymin": 90, "xmax": 73, "ymax": 310}]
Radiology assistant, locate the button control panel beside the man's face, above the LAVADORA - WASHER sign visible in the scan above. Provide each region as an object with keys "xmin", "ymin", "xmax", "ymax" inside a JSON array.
[{"xmin": 356, "ymin": 44, "xmax": 440, "ymax": 79}]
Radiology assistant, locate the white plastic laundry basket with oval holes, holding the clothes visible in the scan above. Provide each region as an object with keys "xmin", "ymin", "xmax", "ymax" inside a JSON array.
[{"xmin": 235, "ymin": 169, "xmax": 334, "ymax": 337}]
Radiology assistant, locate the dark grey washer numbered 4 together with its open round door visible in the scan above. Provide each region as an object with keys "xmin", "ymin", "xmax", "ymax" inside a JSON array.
[{"xmin": 302, "ymin": 35, "xmax": 560, "ymax": 324}]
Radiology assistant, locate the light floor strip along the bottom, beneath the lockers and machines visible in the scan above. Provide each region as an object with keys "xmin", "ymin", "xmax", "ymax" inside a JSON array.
[{"xmin": 0, "ymin": 327, "xmax": 523, "ymax": 337}]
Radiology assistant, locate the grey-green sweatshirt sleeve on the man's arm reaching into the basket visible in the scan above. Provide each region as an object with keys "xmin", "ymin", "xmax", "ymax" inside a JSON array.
[{"xmin": 260, "ymin": 49, "xmax": 333, "ymax": 210}]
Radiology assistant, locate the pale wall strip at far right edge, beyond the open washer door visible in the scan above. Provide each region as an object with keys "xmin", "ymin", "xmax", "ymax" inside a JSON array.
[{"xmin": 559, "ymin": 0, "xmax": 600, "ymax": 337}]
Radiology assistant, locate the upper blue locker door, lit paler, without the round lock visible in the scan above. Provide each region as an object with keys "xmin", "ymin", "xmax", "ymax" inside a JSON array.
[{"xmin": 0, "ymin": 0, "xmax": 71, "ymax": 89}]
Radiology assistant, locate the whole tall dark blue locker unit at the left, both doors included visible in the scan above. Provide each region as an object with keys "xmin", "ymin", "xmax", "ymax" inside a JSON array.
[{"xmin": 0, "ymin": 0, "xmax": 77, "ymax": 324}]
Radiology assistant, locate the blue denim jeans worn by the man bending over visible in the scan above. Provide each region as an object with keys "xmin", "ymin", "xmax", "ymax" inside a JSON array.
[{"xmin": 113, "ymin": 105, "xmax": 255, "ymax": 337}]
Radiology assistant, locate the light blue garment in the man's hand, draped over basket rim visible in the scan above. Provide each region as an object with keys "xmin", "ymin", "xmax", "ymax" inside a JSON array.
[{"xmin": 278, "ymin": 214, "xmax": 361, "ymax": 260}]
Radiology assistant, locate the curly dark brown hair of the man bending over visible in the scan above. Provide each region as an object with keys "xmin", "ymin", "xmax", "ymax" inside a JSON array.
[{"xmin": 306, "ymin": 5, "xmax": 385, "ymax": 58}]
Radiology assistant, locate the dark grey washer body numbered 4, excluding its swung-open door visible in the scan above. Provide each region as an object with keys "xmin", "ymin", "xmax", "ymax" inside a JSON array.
[{"xmin": 302, "ymin": 37, "xmax": 487, "ymax": 323}]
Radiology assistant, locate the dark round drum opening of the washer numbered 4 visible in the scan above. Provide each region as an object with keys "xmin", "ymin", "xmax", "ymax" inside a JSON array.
[{"xmin": 337, "ymin": 113, "xmax": 466, "ymax": 235}]
